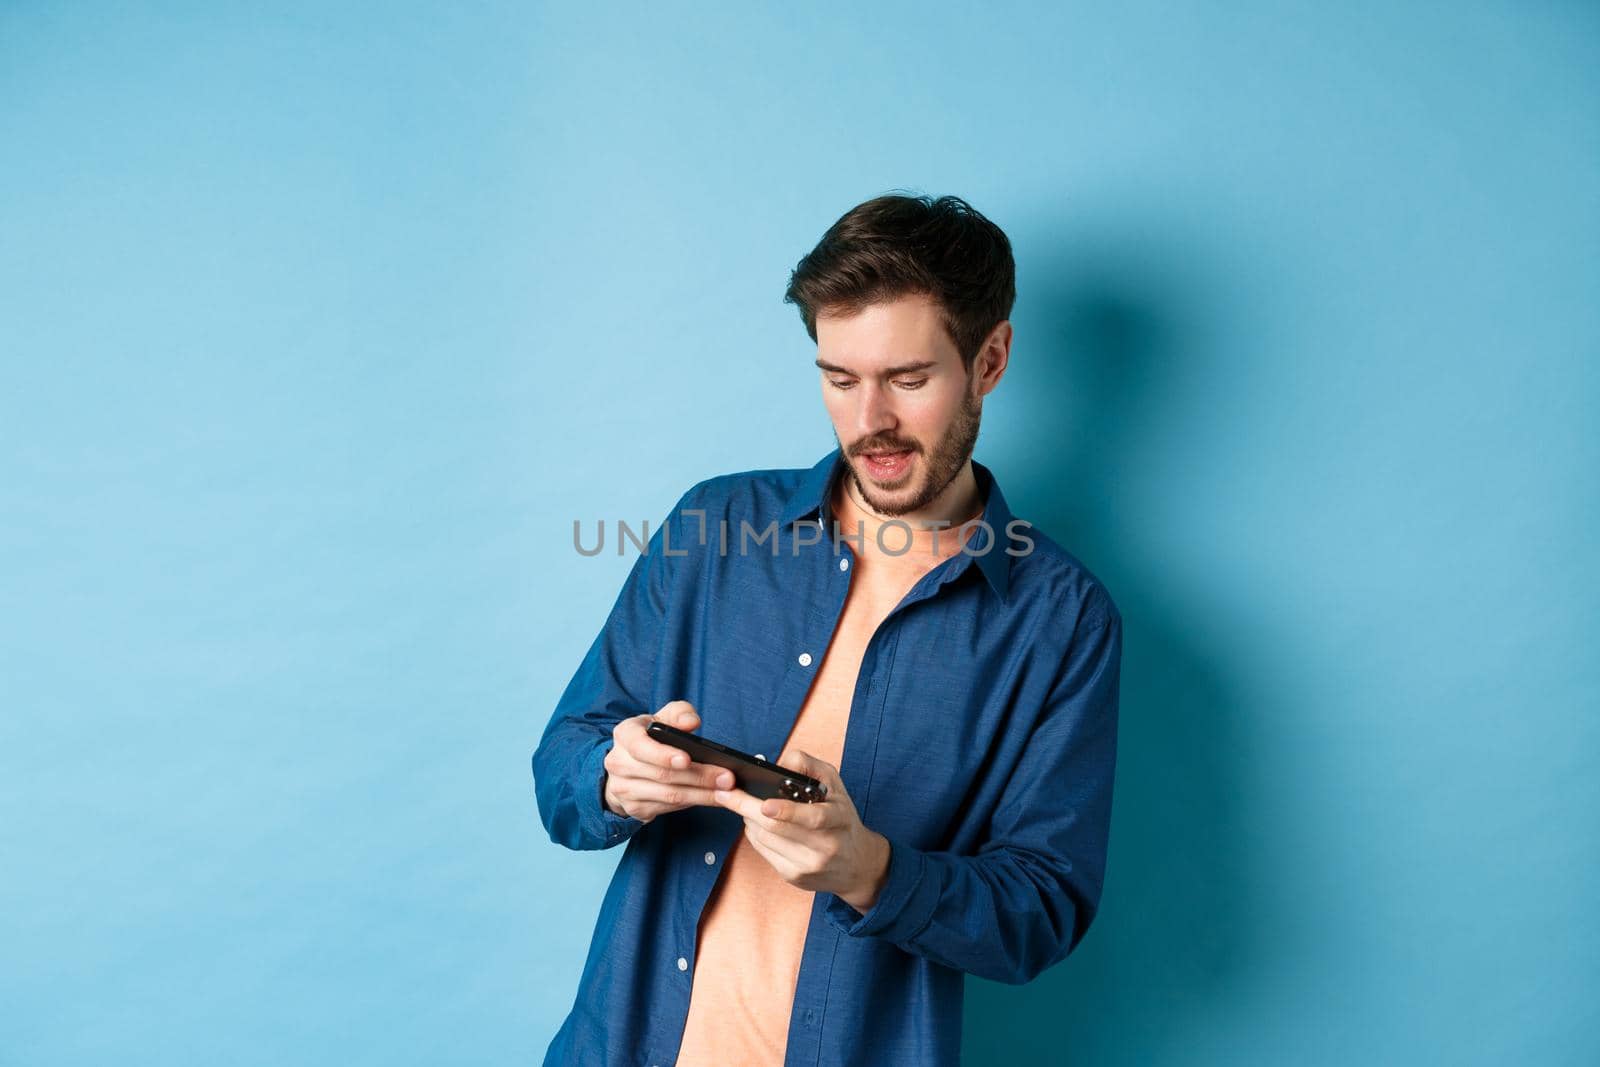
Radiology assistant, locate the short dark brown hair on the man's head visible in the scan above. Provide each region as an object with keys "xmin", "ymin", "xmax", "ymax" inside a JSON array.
[{"xmin": 784, "ymin": 194, "xmax": 1016, "ymax": 370}]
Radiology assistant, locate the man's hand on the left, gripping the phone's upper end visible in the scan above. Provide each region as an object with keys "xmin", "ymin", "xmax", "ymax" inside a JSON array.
[{"xmin": 605, "ymin": 701, "xmax": 733, "ymax": 822}]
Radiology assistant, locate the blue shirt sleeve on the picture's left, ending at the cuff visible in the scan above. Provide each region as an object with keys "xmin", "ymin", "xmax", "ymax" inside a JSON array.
[{"xmin": 533, "ymin": 493, "xmax": 690, "ymax": 849}]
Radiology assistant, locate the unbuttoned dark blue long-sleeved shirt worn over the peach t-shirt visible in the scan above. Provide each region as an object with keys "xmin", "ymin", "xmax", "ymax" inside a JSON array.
[{"xmin": 533, "ymin": 448, "xmax": 1122, "ymax": 1067}]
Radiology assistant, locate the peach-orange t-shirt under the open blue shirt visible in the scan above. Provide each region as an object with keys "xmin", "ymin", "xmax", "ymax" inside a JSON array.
[{"xmin": 677, "ymin": 482, "xmax": 981, "ymax": 1067}]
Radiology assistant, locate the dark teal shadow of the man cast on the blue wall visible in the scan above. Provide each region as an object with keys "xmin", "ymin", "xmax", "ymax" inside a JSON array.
[{"xmin": 963, "ymin": 250, "xmax": 1277, "ymax": 1067}]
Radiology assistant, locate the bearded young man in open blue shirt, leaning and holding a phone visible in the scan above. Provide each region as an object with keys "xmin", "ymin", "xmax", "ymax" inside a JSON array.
[{"xmin": 533, "ymin": 195, "xmax": 1122, "ymax": 1067}]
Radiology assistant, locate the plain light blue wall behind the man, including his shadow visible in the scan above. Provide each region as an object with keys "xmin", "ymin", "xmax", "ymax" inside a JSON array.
[{"xmin": 0, "ymin": 2, "xmax": 1600, "ymax": 1067}]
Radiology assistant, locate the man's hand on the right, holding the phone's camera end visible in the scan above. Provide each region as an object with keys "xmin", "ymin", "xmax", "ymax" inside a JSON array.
[{"xmin": 712, "ymin": 752, "xmax": 890, "ymax": 913}]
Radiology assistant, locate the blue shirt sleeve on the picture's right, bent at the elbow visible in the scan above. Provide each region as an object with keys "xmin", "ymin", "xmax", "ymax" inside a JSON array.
[{"xmin": 824, "ymin": 611, "xmax": 1122, "ymax": 985}]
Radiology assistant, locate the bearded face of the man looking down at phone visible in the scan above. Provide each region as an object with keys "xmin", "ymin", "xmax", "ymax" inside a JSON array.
[{"xmin": 816, "ymin": 296, "xmax": 982, "ymax": 515}]
